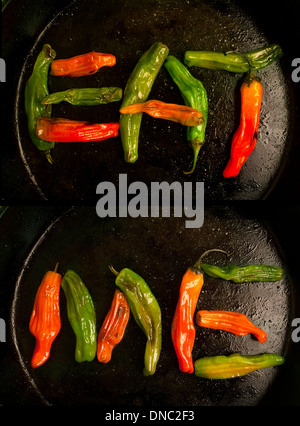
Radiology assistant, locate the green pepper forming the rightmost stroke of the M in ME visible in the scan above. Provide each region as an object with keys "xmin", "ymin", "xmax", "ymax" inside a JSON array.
[{"xmin": 111, "ymin": 267, "xmax": 162, "ymax": 376}]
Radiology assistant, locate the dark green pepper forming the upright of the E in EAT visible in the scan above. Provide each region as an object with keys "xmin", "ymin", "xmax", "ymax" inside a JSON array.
[{"xmin": 25, "ymin": 44, "xmax": 56, "ymax": 163}]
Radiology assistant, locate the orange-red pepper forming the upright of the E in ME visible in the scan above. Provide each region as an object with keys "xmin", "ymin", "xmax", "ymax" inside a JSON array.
[{"xmin": 171, "ymin": 256, "xmax": 203, "ymax": 373}]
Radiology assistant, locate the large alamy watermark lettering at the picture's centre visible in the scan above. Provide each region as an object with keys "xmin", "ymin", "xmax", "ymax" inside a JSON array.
[{"xmin": 96, "ymin": 174, "xmax": 204, "ymax": 228}]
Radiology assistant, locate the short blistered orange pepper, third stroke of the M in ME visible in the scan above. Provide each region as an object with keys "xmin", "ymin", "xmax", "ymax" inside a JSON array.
[{"xmin": 97, "ymin": 289, "xmax": 130, "ymax": 364}]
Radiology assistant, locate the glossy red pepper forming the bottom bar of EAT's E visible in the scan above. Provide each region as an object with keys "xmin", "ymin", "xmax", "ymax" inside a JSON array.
[{"xmin": 36, "ymin": 118, "xmax": 120, "ymax": 142}]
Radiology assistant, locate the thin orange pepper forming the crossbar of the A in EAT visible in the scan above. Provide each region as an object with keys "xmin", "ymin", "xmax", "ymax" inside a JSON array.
[{"xmin": 120, "ymin": 100, "xmax": 204, "ymax": 126}]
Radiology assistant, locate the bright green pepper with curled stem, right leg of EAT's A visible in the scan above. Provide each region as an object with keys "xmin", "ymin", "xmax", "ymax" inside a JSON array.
[{"xmin": 164, "ymin": 55, "xmax": 208, "ymax": 174}]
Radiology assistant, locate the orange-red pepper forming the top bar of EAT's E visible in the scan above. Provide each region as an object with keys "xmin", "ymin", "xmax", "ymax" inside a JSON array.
[{"xmin": 51, "ymin": 52, "xmax": 116, "ymax": 77}]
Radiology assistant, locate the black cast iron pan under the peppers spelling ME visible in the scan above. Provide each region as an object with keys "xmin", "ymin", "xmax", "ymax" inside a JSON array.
[{"xmin": 11, "ymin": 207, "xmax": 295, "ymax": 407}]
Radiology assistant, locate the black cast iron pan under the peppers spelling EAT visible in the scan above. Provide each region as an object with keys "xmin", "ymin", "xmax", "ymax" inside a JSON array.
[{"xmin": 3, "ymin": 0, "xmax": 295, "ymax": 202}]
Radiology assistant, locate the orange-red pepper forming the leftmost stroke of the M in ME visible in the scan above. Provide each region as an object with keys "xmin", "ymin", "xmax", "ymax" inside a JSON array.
[{"xmin": 29, "ymin": 266, "xmax": 62, "ymax": 368}]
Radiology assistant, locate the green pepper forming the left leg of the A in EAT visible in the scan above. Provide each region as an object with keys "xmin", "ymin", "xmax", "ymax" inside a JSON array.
[{"xmin": 120, "ymin": 42, "xmax": 169, "ymax": 163}]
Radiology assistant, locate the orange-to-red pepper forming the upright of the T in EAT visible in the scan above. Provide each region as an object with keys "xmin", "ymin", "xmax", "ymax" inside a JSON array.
[{"xmin": 223, "ymin": 77, "xmax": 263, "ymax": 178}]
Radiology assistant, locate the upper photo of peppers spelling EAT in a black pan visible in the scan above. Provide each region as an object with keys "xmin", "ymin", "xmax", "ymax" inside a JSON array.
[{"xmin": 1, "ymin": 0, "xmax": 300, "ymax": 204}]
